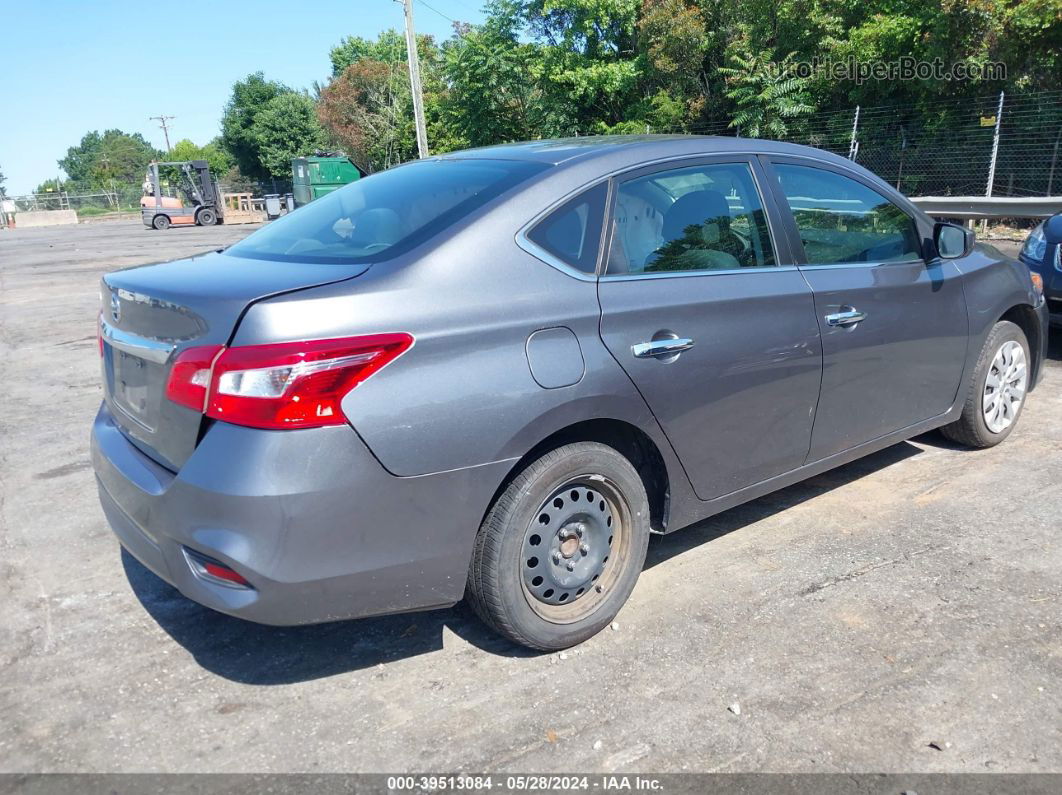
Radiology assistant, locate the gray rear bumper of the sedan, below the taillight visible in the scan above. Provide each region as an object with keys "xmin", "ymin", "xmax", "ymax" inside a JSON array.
[{"xmin": 91, "ymin": 405, "xmax": 512, "ymax": 625}]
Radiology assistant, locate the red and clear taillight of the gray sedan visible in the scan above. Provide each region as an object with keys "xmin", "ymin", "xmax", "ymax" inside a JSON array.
[{"xmin": 167, "ymin": 333, "xmax": 413, "ymax": 429}]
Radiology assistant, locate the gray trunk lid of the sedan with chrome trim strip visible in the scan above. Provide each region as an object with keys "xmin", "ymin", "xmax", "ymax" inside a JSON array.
[{"xmin": 100, "ymin": 253, "xmax": 369, "ymax": 471}]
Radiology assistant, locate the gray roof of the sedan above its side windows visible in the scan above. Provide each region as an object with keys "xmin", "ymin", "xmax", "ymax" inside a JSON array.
[{"xmin": 440, "ymin": 135, "xmax": 852, "ymax": 170}]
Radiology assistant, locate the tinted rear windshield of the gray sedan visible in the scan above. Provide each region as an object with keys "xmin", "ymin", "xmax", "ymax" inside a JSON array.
[{"xmin": 225, "ymin": 160, "xmax": 546, "ymax": 262}]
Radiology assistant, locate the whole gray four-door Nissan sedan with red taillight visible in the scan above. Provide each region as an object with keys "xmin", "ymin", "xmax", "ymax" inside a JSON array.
[{"xmin": 92, "ymin": 136, "xmax": 1047, "ymax": 650}]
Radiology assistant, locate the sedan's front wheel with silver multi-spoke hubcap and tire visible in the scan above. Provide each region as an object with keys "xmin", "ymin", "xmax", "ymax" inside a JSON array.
[{"xmin": 940, "ymin": 321, "xmax": 1032, "ymax": 449}]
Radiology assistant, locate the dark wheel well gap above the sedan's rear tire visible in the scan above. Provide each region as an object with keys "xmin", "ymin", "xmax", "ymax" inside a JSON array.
[{"xmin": 483, "ymin": 418, "xmax": 671, "ymax": 533}]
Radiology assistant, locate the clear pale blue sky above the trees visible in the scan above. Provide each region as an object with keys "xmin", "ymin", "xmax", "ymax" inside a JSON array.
[{"xmin": 0, "ymin": 0, "xmax": 483, "ymax": 195}]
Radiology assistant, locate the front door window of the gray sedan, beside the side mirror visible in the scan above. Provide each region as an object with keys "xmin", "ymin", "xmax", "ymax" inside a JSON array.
[{"xmin": 773, "ymin": 162, "xmax": 922, "ymax": 265}]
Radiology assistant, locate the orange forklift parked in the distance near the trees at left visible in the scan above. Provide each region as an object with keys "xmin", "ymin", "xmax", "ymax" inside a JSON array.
[{"xmin": 140, "ymin": 160, "xmax": 225, "ymax": 229}]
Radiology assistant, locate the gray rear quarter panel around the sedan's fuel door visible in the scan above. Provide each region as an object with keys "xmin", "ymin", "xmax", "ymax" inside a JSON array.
[{"xmin": 234, "ymin": 201, "xmax": 688, "ymax": 520}]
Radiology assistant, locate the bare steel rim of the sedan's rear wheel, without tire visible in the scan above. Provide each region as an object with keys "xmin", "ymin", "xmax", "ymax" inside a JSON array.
[{"xmin": 519, "ymin": 474, "xmax": 631, "ymax": 624}]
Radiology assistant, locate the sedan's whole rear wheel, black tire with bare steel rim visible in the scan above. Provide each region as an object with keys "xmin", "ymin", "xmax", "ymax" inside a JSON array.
[{"xmin": 467, "ymin": 442, "xmax": 649, "ymax": 651}]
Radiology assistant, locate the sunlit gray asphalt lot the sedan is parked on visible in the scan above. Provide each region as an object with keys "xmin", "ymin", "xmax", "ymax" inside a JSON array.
[{"xmin": 0, "ymin": 222, "xmax": 1062, "ymax": 773}]
